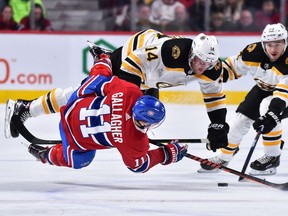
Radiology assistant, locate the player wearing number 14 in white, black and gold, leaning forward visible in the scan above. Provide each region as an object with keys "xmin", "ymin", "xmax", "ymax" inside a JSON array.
[{"xmin": 5, "ymin": 29, "xmax": 229, "ymax": 154}]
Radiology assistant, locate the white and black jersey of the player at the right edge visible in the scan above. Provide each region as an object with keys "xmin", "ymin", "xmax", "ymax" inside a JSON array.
[{"xmin": 222, "ymin": 42, "xmax": 288, "ymax": 104}]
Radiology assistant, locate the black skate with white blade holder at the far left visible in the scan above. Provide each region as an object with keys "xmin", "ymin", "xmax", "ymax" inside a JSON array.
[{"xmin": 4, "ymin": 100, "xmax": 31, "ymax": 138}]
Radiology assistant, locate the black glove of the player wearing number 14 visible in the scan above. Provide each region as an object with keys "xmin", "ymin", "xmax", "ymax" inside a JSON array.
[{"xmin": 206, "ymin": 123, "xmax": 229, "ymax": 152}]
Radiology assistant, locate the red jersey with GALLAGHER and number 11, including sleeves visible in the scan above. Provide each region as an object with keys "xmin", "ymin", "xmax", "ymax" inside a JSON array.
[{"xmin": 60, "ymin": 75, "xmax": 163, "ymax": 172}]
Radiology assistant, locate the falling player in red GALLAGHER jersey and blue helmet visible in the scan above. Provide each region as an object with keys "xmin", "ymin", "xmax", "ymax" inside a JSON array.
[{"xmin": 28, "ymin": 54, "xmax": 187, "ymax": 172}]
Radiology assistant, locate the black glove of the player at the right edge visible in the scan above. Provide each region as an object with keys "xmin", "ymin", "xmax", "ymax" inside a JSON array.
[{"xmin": 253, "ymin": 110, "xmax": 281, "ymax": 134}]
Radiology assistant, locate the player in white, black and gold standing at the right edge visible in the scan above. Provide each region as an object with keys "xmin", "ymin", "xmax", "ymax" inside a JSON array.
[{"xmin": 199, "ymin": 23, "xmax": 288, "ymax": 175}]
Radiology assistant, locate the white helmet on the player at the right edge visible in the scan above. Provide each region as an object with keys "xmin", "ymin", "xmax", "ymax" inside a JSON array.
[{"xmin": 261, "ymin": 23, "xmax": 287, "ymax": 52}]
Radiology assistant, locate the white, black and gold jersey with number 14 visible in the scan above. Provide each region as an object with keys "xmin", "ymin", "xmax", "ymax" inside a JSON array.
[{"xmin": 121, "ymin": 29, "xmax": 226, "ymax": 115}]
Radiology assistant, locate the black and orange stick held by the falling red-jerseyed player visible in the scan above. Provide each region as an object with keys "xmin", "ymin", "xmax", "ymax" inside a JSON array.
[{"xmin": 151, "ymin": 138, "xmax": 288, "ymax": 191}]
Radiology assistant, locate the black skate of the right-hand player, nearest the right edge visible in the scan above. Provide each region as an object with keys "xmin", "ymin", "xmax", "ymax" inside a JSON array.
[{"xmin": 249, "ymin": 154, "xmax": 280, "ymax": 175}]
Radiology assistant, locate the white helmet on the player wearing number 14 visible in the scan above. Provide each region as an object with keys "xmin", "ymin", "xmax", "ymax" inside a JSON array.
[{"xmin": 188, "ymin": 33, "xmax": 220, "ymax": 70}]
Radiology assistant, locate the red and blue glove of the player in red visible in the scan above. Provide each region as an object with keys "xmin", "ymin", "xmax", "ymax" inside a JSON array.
[{"xmin": 161, "ymin": 140, "xmax": 188, "ymax": 165}]
